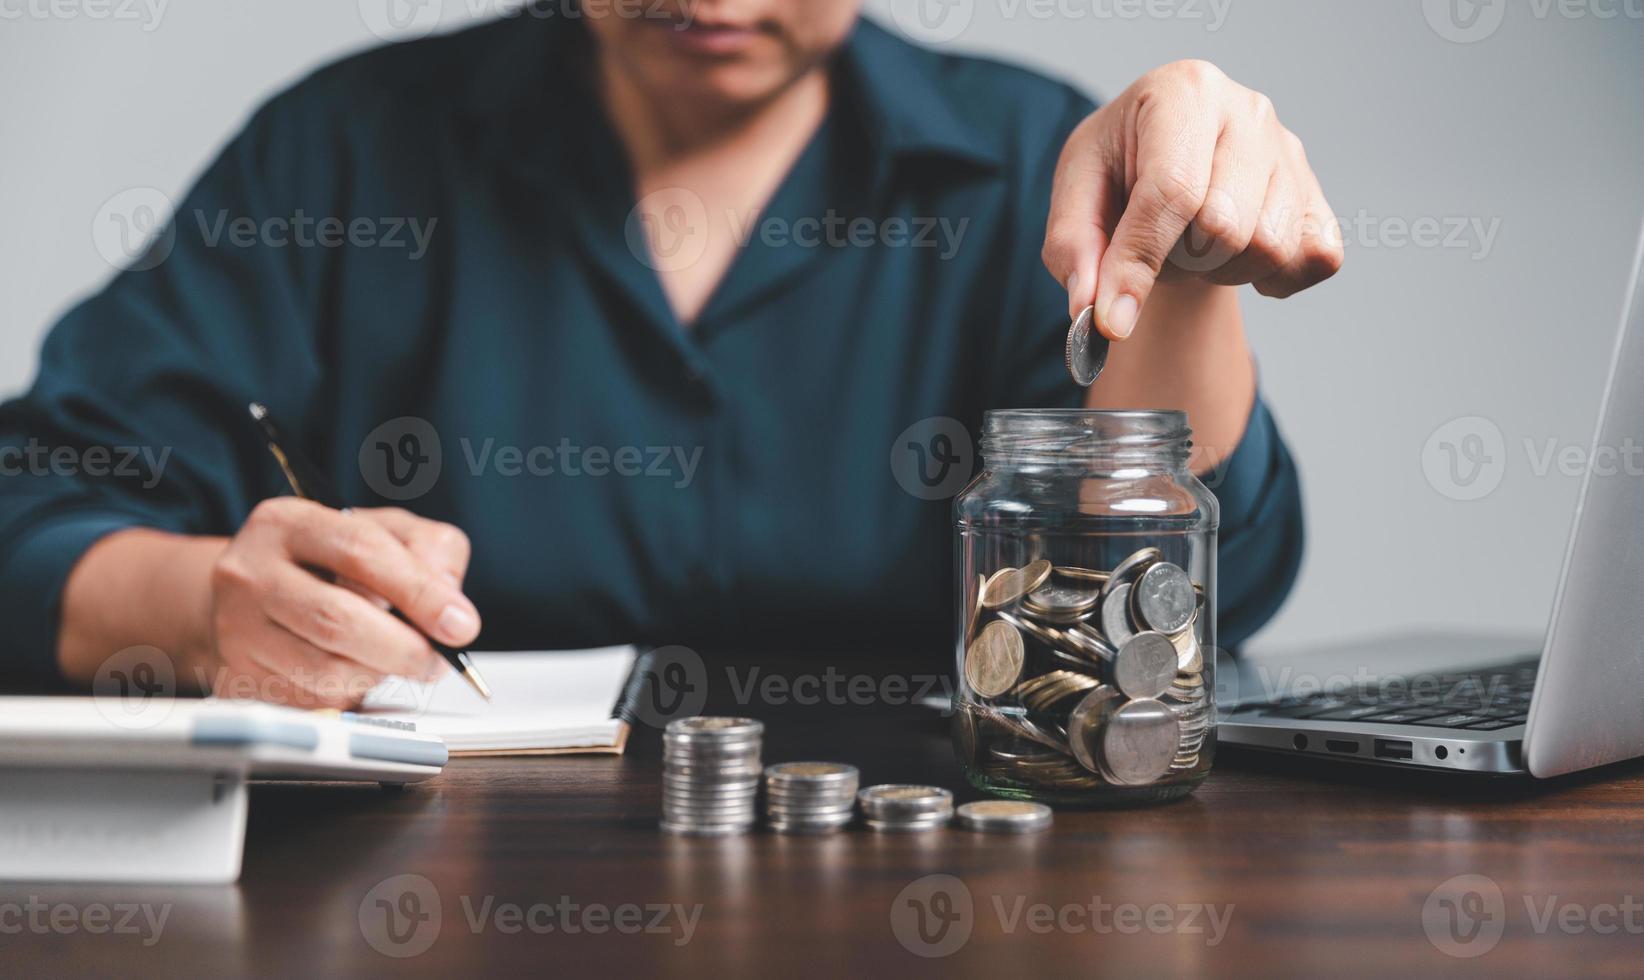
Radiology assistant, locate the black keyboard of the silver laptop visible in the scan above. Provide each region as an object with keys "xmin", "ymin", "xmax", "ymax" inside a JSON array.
[{"xmin": 1254, "ymin": 658, "xmax": 1540, "ymax": 732}]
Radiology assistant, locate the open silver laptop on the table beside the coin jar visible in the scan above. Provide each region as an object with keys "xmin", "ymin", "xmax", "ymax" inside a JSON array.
[{"xmin": 1217, "ymin": 218, "xmax": 1644, "ymax": 778}]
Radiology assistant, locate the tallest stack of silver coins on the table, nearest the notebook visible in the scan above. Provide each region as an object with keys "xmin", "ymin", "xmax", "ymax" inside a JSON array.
[{"xmin": 663, "ymin": 717, "xmax": 764, "ymax": 837}]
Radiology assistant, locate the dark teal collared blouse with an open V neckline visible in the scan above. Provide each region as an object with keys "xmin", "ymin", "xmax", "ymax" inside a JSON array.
[{"xmin": 0, "ymin": 18, "xmax": 1302, "ymax": 690}]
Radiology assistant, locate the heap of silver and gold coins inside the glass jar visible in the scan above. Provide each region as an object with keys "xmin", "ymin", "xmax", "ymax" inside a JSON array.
[{"xmin": 954, "ymin": 548, "xmax": 1215, "ymax": 791}]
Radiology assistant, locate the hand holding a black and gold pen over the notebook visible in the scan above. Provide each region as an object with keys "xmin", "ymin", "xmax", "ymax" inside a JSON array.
[{"xmin": 209, "ymin": 497, "xmax": 480, "ymax": 707}]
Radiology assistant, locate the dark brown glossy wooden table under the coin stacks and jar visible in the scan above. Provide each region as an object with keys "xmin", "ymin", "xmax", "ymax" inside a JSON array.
[{"xmin": 0, "ymin": 684, "xmax": 1644, "ymax": 978}]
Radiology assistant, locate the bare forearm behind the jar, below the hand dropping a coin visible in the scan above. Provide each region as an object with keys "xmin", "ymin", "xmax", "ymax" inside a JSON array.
[{"xmin": 1087, "ymin": 280, "xmax": 1256, "ymax": 474}]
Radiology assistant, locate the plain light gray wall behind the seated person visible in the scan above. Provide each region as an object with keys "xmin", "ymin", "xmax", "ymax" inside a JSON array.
[{"xmin": 0, "ymin": 0, "xmax": 1644, "ymax": 646}]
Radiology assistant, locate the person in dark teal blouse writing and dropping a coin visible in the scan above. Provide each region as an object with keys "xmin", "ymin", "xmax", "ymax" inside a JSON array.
[{"xmin": 0, "ymin": 0, "xmax": 1342, "ymax": 705}]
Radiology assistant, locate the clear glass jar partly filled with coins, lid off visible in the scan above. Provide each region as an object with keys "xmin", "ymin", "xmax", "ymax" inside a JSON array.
[{"xmin": 954, "ymin": 409, "xmax": 1218, "ymax": 806}]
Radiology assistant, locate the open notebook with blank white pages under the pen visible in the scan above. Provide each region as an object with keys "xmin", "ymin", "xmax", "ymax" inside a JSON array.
[{"xmin": 365, "ymin": 646, "xmax": 644, "ymax": 755}]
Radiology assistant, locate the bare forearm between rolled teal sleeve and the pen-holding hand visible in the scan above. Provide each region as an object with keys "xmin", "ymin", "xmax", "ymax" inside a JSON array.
[{"xmin": 58, "ymin": 528, "xmax": 229, "ymax": 691}]
